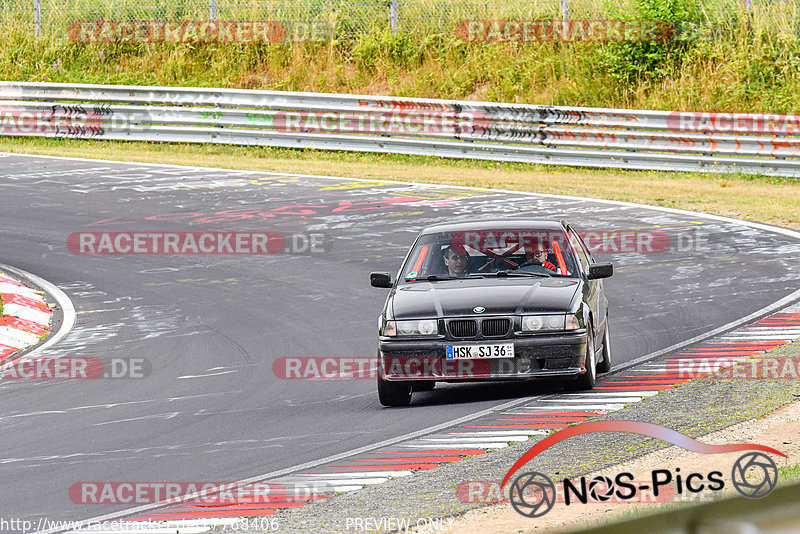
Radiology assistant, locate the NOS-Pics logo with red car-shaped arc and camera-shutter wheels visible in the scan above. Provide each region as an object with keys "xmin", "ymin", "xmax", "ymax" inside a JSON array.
[{"xmin": 502, "ymin": 421, "xmax": 786, "ymax": 518}]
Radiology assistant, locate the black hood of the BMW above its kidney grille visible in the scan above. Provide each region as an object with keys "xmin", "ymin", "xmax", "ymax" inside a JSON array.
[{"xmin": 392, "ymin": 278, "xmax": 582, "ymax": 319}]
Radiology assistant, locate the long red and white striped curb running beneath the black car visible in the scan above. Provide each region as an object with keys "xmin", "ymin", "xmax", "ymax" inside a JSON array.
[{"xmin": 56, "ymin": 303, "xmax": 800, "ymax": 534}]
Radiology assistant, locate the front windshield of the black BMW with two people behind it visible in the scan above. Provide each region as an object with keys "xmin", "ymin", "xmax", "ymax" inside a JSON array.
[{"xmin": 402, "ymin": 229, "xmax": 577, "ymax": 281}]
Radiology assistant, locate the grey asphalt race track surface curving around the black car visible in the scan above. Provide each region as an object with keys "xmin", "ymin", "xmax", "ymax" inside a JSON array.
[{"xmin": 0, "ymin": 155, "xmax": 800, "ymax": 532}]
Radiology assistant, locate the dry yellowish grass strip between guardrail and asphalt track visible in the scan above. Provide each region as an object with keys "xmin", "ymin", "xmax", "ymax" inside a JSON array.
[{"xmin": 0, "ymin": 137, "xmax": 800, "ymax": 228}]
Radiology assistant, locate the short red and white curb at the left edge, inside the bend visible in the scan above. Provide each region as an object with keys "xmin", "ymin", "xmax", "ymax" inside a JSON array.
[{"xmin": 0, "ymin": 271, "xmax": 53, "ymax": 363}]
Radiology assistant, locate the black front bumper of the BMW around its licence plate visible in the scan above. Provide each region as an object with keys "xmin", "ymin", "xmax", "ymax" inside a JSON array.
[{"xmin": 378, "ymin": 331, "xmax": 587, "ymax": 382}]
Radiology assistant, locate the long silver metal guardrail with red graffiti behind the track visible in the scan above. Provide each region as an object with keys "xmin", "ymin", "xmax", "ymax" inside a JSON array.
[{"xmin": 0, "ymin": 82, "xmax": 800, "ymax": 176}]
